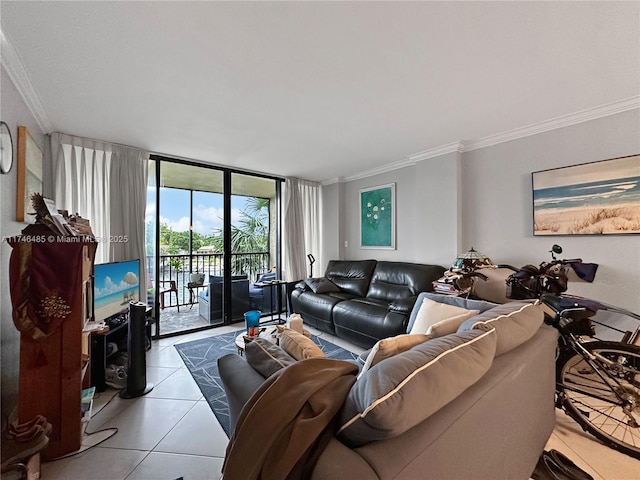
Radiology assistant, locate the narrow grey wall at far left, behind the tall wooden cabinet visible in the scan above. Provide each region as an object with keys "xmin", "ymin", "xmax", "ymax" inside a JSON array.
[{"xmin": 0, "ymin": 67, "xmax": 46, "ymax": 418}]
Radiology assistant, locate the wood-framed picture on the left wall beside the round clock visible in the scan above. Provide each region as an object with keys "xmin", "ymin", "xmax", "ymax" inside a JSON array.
[{"xmin": 16, "ymin": 126, "xmax": 44, "ymax": 223}]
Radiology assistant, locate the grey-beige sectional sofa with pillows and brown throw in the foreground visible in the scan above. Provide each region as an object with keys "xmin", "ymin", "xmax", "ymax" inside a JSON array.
[{"xmin": 219, "ymin": 294, "xmax": 557, "ymax": 480}]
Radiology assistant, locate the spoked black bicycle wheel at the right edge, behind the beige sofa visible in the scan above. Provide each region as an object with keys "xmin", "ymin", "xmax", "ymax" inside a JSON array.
[{"xmin": 556, "ymin": 341, "xmax": 640, "ymax": 459}]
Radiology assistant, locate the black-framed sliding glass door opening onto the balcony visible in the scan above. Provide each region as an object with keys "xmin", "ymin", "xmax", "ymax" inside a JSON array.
[{"xmin": 147, "ymin": 158, "xmax": 279, "ymax": 336}]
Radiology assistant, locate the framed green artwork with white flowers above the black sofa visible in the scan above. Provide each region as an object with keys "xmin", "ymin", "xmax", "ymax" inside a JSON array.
[{"xmin": 359, "ymin": 183, "xmax": 396, "ymax": 250}]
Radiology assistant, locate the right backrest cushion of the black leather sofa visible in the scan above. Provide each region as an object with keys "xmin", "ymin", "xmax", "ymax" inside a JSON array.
[{"xmin": 367, "ymin": 262, "xmax": 445, "ymax": 301}]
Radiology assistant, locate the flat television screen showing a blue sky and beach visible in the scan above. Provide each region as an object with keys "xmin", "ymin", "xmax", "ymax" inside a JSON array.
[{"xmin": 93, "ymin": 260, "xmax": 140, "ymax": 322}]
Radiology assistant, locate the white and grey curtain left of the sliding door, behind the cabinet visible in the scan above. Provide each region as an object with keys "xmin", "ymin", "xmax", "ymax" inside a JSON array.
[{"xmin": 51, "ymin": 133, "xmax": 149, "ymax": 290}]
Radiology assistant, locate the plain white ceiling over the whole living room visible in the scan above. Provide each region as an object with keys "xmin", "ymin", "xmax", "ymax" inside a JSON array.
[{"xmin": 0, "ymin": 0, "xmax": 640, "ymax": 181}]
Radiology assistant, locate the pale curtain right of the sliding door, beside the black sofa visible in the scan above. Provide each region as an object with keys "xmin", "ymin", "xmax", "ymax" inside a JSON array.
[{"xmin": 283, "ymin": 178, "xmax": 324, "ymax": 281}]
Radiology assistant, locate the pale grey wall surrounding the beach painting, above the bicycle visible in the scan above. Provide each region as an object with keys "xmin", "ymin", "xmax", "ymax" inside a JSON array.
[{"xmin": 462, "ymin": 109, "xmax": 640, "ymax": 312}]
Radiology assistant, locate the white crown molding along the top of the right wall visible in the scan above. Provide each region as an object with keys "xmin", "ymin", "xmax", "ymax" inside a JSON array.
[{"xmin": 464, "ymin": 95, "xmax": 640, "ymax": 152}]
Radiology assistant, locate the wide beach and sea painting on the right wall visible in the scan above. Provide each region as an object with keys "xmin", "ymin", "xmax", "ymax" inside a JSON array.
[{"xmin": 531, "ymin": 154, "xmax": 640, "ymax": 236}]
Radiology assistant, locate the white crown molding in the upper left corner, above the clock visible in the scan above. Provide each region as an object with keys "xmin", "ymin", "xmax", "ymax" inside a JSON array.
[{"xmin": 0, "ymin": 28, "xmax": 53, "ymax": 133}]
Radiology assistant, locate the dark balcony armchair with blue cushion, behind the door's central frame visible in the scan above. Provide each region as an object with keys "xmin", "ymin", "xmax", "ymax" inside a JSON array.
[{"xmin": 198, "ymin": 275, "xmax": 251, "ymax": 325}]
